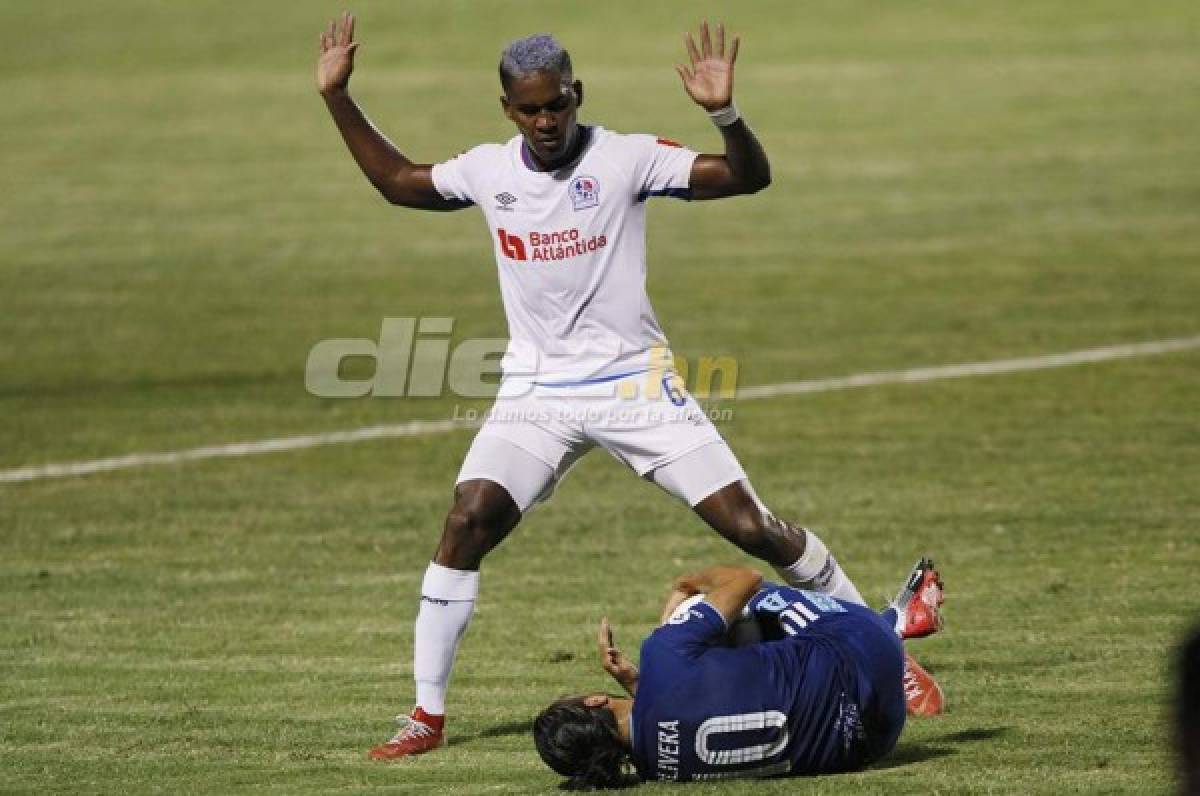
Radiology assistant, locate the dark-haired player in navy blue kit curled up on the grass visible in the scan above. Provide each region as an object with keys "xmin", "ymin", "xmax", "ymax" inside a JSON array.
[{"xmin": 533, "ymin": 558, "xmax": 942, "ymax": 789}]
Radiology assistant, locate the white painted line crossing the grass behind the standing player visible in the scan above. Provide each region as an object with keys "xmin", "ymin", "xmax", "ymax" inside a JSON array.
[{"xmin": 0, "ymin": 335, "xmax": 1200, "ymax": 484}]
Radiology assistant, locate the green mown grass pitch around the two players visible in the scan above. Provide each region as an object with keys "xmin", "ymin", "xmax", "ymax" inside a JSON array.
[{"xmin": 0, "ymin": 0, "xmax": 1200, "ymax": 794}]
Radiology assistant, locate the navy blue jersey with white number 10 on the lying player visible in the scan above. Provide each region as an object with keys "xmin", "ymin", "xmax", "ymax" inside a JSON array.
[{"xmin": 632, "ymin": 583, "xmax": 905, "ymax": 782}]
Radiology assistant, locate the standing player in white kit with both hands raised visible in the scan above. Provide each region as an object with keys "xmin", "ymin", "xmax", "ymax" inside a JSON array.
[{"xmin": 317, "ymin": 14, "xmax": 936, "ymax": 760}]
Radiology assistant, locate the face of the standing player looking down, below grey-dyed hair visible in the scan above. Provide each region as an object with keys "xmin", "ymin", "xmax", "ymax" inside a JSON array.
[{"xmin": 500, "ymin": 72, "xmax": 583, "ymax": 167}]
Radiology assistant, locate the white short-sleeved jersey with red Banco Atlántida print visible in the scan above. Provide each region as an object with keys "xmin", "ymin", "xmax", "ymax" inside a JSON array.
[{"xmin": 433, "ymin": 125, "xmax": 696, "ymax": 383}]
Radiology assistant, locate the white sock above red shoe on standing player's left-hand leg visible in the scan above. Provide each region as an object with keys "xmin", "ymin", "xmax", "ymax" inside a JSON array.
[{"xmin": 413, "ymin": 561, "xmax": 479, "ymax": 716}]
